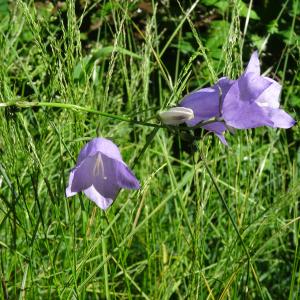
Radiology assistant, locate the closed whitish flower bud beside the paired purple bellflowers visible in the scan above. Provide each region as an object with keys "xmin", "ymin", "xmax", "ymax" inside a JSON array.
[{"xmin": 158, "ymin": 107, "xmax": 194, "ymax": 125}]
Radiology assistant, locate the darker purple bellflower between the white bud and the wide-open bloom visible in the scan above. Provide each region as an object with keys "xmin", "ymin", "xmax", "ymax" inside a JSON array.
[{"xmin": 179, "ymin": 77, "xmax": 234, "ymax": 145}]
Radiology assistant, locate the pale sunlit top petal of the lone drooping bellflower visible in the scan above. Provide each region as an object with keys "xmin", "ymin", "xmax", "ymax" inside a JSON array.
[{"xmin": 77, "ymin": 137, "xmax": 122, "ymax": 165}]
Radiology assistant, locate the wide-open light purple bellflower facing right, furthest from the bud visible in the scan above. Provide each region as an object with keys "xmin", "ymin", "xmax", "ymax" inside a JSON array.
[{"xmin": 222, "ymin": 52, "xmax": 295, "ymax": 129}]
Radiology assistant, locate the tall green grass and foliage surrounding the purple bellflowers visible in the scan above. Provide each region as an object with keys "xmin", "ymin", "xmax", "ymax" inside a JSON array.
[{"xmin": 0, "ymin": 0, "xmax": 300, "ymax": 299}]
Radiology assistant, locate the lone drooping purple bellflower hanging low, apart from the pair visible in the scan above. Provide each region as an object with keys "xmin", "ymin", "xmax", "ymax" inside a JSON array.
[{"xmin": 66, "ymin": 138, "xmax": 140, "ymax": 210}]
